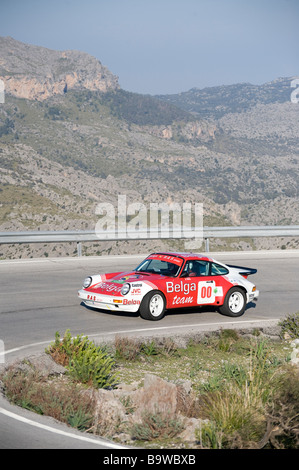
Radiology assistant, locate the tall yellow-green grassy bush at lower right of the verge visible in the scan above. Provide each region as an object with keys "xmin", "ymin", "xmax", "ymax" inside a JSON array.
[{"xmin": 196, "ymin": 341, "xmax": 275, "ymax": 448}]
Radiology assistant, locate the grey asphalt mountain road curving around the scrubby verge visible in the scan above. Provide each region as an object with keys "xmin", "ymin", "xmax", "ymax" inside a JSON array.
[{"xmin": 0, "ymin": 251, "xmax": 299, "ymax": 449}]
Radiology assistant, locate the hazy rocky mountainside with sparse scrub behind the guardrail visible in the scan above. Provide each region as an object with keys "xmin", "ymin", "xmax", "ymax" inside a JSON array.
[{"xmin": 0, "ymin": 38, "xmax": 299, "ymax": 258}]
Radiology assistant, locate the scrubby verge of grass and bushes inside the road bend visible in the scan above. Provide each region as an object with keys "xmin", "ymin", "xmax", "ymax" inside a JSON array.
[{"xmin": 1, "ymin": 314, "xmax": 299, "ymax": 449}]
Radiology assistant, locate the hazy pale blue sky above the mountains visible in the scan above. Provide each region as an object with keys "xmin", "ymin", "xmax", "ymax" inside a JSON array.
[{"xmin": 0, "ymin": 0, "xmax": 299, "ymax": 95}]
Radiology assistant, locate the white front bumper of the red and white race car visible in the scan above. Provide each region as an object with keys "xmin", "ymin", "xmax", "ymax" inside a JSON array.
[{"xmin": 78, "ymin": 289, "xmax": 140, "ymax": 312}]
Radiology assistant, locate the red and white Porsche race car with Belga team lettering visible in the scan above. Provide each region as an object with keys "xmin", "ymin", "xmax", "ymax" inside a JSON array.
[{"xmin": 78, "ymin": 253, "xmax": 259, "ymax": 320}]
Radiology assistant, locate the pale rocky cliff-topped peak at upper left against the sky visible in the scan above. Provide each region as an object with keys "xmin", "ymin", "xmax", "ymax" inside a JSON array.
[{"xmin": 0, "ymin": 37, "xmax": 119, "ymax": 101}]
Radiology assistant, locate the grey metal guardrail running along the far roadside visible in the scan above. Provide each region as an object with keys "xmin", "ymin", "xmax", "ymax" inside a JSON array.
[{"xmin": 0, "ymin": 225, "xmax": 299, "ymax": 256}]
